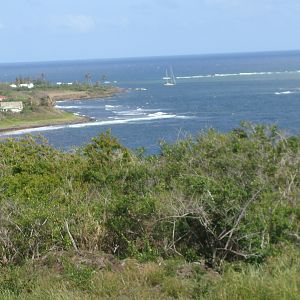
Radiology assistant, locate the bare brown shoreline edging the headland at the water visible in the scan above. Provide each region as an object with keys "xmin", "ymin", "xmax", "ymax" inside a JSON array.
[{"xmin": 0, "ymin": 88, "xmax": 126, "ymax": 134}]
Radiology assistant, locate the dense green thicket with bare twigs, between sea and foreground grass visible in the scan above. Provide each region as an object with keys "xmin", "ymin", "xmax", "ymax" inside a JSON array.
[{"xmin": 0, "ymin": 124, "xmax": 300, "ymax": 267}]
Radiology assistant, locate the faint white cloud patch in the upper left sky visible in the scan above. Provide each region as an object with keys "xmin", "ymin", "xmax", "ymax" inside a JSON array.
[{"xmin": 51, "ymin": 14, "xmax": 96, "ymax": 33}]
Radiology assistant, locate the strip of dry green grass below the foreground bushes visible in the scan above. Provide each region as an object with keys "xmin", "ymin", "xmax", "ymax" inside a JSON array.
[{"xmin": 0, "ymin": 247, "xmax": 300, "ymax": 300}]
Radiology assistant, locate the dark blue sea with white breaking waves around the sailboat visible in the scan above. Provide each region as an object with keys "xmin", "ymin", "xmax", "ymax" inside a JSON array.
[{"xmin": 0, "ymin": 52, "xmax": 300, "ymax": 152}]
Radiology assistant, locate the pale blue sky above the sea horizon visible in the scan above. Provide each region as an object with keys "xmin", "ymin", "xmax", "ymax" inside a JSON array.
[{"xmin": 0, "ymin": 0, "xmax": 300, "ymax": 63}]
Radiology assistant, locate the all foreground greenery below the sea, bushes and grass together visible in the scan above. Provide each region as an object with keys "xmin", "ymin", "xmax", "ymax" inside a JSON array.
[{"xmin": 0, "ymin": 124, "xmax": 300, "ymax": 299}]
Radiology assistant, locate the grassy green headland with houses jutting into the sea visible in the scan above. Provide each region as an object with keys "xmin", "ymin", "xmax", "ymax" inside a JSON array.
[{"xmin": 0, "ymin": 83, "xmax": 121, "ymax": 132}]
